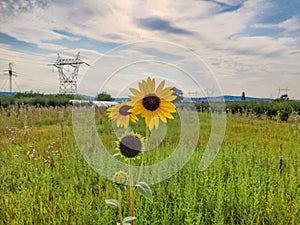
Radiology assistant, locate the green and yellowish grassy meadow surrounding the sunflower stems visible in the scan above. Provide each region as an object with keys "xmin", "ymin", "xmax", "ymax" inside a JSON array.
[{"xmin": 0, "ymin": 106, "xmax": 300, "ymax": 225}]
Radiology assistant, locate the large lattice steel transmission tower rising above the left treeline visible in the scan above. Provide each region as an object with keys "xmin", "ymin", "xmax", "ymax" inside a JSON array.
[{"xmin": 49, "ymin": 52, "xmax": 90, "ymax": 94}]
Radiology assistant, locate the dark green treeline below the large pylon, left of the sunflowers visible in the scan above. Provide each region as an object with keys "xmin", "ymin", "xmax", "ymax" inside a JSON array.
[{"xmin": 0, "ymin": 92, "xmax": 74, "ymax": 108}]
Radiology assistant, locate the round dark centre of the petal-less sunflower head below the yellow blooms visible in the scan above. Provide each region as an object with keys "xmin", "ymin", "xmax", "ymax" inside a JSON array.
[{"xmin": 120, "ymin": 135, "xmax": 142, "ymax": 158}]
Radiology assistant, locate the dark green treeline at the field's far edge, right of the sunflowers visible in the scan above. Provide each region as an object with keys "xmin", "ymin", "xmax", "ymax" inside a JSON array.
[{"xmin": 196, "ymin": 100, "xmax": 300, "ymax": 121}]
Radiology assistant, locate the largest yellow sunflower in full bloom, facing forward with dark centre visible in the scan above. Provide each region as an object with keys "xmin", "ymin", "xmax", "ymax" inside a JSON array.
[{"xmin": 129, "ymin": 77, "xmax": 176, "ymax": 130}]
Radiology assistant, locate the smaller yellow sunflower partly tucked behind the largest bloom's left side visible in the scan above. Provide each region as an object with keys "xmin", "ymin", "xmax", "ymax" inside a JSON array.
[{"xmin": 107, "ymin": 101, "xmax": 138, "ymax": 128}]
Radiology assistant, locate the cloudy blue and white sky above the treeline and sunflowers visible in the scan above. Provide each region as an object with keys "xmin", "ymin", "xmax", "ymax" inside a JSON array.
[{"xmin": 0, "ymin": 0, "xmax": 300, "ymax": 99}]
